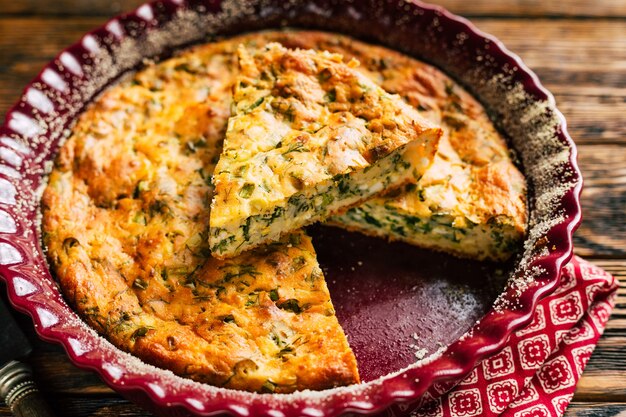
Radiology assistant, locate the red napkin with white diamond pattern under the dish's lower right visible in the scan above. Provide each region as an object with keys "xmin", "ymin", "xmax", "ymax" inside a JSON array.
[{"xmin": 412, "ymin": 257, "xmax": 618, "ymax": 417}]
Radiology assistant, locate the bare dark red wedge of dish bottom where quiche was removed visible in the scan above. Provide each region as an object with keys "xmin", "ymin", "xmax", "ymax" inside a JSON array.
[{"xmin": 309, "ymin": 226, "xmax": 510, "ymax": 381}]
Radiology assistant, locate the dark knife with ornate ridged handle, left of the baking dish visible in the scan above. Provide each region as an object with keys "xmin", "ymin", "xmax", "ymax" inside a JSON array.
[{"xmin": 0, "ymin": 299, "xmax": 53, "ymax": 417}]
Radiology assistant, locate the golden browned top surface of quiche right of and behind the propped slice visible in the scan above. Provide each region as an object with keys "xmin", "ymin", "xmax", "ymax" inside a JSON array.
[{"xmin": 264, "ymin": 32, "xmax": 528, "ymax": 234}]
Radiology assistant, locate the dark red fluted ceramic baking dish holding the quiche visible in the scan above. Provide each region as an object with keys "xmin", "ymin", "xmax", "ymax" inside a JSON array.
[{"xmin": 0, "ymin": 0, "xmax": 582, "ymax": 417}]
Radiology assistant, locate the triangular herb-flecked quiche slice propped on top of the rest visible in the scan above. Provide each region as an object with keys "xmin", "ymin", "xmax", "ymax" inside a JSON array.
[{"xmin": 209, "ymin": 43, "xmax": 441, "ymax": 258}]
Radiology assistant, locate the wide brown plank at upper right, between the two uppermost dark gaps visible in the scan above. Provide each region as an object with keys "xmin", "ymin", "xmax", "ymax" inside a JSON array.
[{"xmin": 467, "ymin": 18, "xmax": 626, "ymax": 143}]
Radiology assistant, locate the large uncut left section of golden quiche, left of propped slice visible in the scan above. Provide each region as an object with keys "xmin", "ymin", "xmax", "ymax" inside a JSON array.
[{"xmin": 42, "ymin": 35, "xmax": 359, "ymax": 393}]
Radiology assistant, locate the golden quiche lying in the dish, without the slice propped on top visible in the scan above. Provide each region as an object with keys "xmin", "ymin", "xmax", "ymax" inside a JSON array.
[{"xmin": 42, "ymin": 31, "xmax": 526, "ymax": 392}]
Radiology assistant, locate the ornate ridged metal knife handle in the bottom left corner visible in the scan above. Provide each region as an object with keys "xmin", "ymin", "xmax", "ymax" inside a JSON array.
[{"xmin": 0, "ymin": 361, "xmax": 54, "ymax": 417}]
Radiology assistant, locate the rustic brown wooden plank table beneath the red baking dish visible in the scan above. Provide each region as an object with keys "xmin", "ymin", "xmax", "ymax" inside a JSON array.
[{"xmin": 0, "ymin": 0, "xmax": 626, "ymax": 416}]
